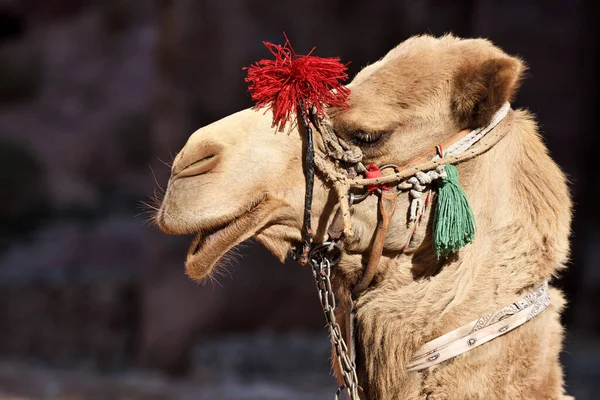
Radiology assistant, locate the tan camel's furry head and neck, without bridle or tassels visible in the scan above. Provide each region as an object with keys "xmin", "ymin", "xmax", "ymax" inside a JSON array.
[{"xmin": 156, "ymin": 35, "xmax": 571, "ymax": 400}]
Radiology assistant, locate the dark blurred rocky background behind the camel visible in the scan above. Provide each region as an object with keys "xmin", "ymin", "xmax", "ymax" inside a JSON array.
[{"xmin": 0, "ymin": 0, "xmax": 600, "ymax": 400}]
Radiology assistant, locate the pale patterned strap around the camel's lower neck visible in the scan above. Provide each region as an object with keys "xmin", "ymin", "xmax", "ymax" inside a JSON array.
[{"xmin": 407, "ymin": 282, "xmax": 550, "ymax": 371}]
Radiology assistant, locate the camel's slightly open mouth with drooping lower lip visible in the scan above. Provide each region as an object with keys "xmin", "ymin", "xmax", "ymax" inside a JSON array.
[{"xmin": 185, "ymin": 198, "xmax": 268, "ymax": 279}]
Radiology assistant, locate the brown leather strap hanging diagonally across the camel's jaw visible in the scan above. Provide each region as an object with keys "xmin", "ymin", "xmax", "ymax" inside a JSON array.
[{"xmin": 352, "ymin": 191, "xmax": 398, "ymax": 298}]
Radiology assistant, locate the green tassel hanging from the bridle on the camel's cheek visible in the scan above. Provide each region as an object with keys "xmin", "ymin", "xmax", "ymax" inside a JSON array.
[{"xmin": 433, "ymin": 165, "xmax": 475, "ymax": 257}]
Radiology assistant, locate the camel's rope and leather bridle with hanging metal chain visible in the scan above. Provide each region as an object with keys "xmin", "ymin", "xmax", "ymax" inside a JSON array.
[{"xmin": 294, "ymin": 101, "xmax": 510, "ymax": 400}]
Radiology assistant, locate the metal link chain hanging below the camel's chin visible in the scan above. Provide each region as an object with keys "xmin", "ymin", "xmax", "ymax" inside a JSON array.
[{"xmin": 310, "ymin": 243, "xmax": 362, "ymax": 400}]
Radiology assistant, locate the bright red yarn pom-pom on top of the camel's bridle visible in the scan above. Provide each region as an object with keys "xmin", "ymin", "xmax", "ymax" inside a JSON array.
[{"xmin": 244, "ymin": 34, "xmax": 350, "ymax": 130}]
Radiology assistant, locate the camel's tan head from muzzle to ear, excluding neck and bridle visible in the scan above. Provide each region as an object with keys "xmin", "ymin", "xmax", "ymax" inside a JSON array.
[{"xmin": 156, "ymin": 36, "xmax": 523, "ymax": 279}]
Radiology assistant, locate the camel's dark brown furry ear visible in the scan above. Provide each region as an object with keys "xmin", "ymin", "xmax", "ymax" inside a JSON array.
[{"xmin": 451, "ymin": 57, "xmax": 525, "ymax": 129}]
